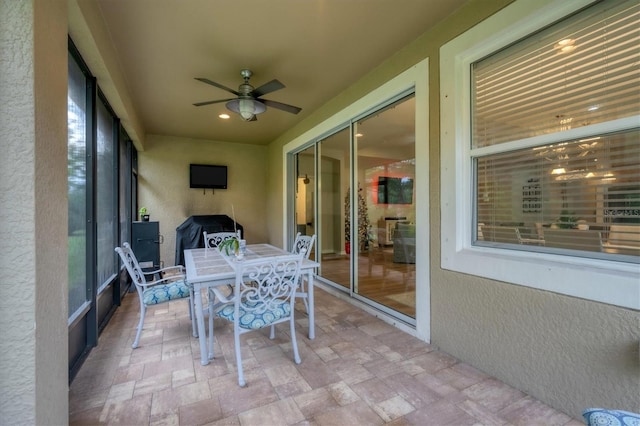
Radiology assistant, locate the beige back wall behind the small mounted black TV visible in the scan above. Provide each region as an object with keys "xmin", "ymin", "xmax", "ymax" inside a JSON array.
[{"xmin": 138, "ymin": 135, "xmax": 269, "ymax": 266}]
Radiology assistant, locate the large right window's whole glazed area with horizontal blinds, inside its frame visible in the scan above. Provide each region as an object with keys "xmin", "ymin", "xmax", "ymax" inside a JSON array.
[{"xmin": 470, "ymin": 0, "xmax": 640, "ymax": 262}]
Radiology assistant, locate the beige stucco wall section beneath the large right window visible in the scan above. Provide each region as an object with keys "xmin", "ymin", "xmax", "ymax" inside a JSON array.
[{"xmin": 431, "ymin": 265, "xmax": 640, "ymax": 417}]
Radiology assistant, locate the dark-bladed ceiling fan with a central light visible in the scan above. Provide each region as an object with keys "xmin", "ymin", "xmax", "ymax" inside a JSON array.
[{"xmin": 193, "ymin": 69, "xmax": 302, "ymax": 121}]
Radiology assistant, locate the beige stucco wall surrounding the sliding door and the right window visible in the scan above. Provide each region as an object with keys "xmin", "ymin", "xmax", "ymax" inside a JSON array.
[{"xmin": 268, "ymin": 0, "xmax": 640, "ymax": 418}]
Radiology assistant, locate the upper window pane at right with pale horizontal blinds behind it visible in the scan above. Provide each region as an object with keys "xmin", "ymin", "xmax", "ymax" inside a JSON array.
[{"xmin": 472, "ymin": 0, "xmax": 640, "ymax": 148}]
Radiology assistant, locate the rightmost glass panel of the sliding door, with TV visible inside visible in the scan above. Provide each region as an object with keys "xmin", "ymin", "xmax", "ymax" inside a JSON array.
[{"xmin": 354, "ymin": 95, "xmax": 416, "ymax": 318}]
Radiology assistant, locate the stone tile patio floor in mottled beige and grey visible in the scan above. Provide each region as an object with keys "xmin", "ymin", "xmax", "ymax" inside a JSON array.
[{"xmin": 69, "ymin": 287, "xmax": 583, "ymax": 426}]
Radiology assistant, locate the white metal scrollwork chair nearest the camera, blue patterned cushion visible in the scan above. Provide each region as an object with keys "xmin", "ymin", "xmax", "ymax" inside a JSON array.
[{"xmin": 209, "ymin": 254, "xmax": 303, "ymax": 387}]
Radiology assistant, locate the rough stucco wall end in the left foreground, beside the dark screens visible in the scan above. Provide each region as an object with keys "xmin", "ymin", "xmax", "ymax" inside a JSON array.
[{"xmin": 0, "ymin": 0, "xmax": 68, "ymax": 425}]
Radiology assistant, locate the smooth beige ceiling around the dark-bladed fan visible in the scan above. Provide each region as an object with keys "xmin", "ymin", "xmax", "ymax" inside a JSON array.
[{"xmin": 94, "ymin": 0, "xmax": 466, "ymax": 144}]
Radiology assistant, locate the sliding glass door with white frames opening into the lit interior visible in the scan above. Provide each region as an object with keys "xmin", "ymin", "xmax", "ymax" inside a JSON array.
[{"xmin": 291, "ymin": 93, "xmax": 416, "ymax": 323}]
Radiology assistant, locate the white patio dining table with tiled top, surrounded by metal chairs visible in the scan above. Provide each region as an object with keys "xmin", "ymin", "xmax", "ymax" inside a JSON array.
[{"xmin": 184, "ymin": 244, "xmax": 320, "ymax": 365}]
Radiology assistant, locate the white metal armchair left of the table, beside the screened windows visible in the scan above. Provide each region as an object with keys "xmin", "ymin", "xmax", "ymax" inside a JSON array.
[{"xmin": 115, "ymin": 243, "xmax": 196, "ymax": 349}]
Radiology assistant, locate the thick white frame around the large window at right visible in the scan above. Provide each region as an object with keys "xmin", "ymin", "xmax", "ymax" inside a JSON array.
[{"xmin": 440, "ymin": 0, "xmax": 640, "ymax": 309}]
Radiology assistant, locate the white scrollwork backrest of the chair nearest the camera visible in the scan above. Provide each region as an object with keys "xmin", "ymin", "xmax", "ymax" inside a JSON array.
[{"xmin": 234, "ymin": 254, "xmax": 303, "ymax": 322}]
